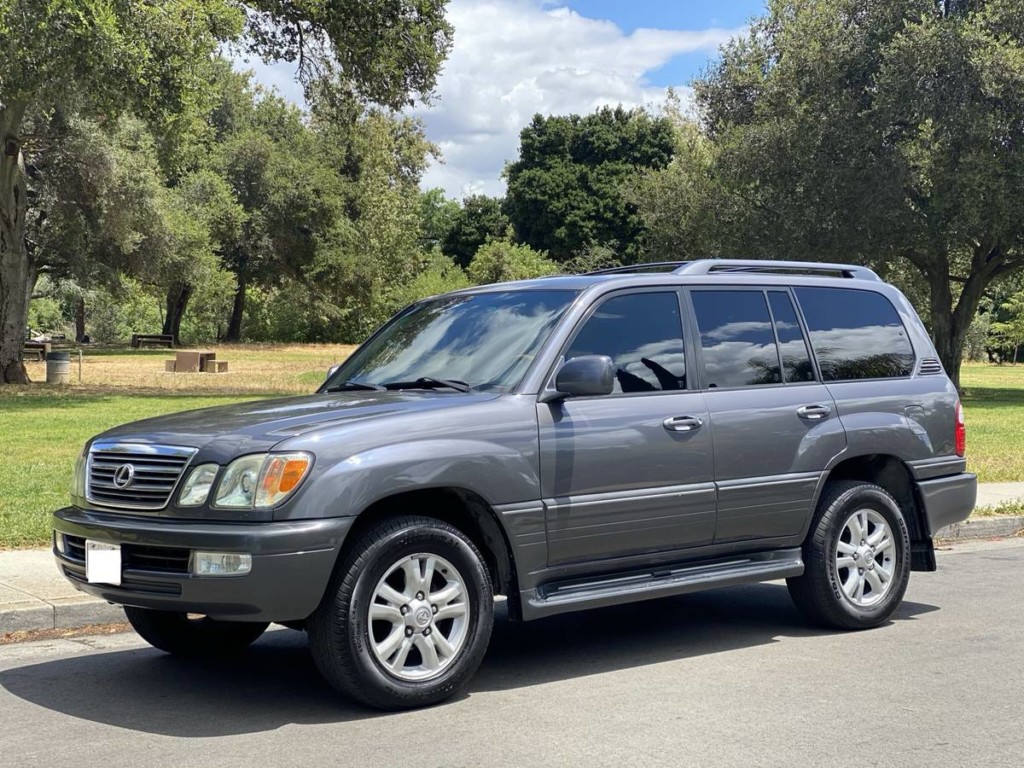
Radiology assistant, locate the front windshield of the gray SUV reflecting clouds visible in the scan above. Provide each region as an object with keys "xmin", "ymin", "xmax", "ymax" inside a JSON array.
[{"xmin": 326, "ymin": 290, "xmax": 577, "ymax": 392}]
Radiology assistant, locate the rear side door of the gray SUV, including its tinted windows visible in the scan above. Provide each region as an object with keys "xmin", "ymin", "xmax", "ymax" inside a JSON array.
[{"xmin": 688, "ymin": 288, "xmax": 846, "ymax": 544}]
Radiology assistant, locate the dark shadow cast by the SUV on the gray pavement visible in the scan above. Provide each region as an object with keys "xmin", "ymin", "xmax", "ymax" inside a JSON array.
[{"xmin": 0, "ymin": 584, "xmax": 938, "ymax": 737}]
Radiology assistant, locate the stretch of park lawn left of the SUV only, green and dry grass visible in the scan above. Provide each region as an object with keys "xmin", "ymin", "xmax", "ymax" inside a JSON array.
[{"xmin": 0, "ymin": 344, "xmax": 352, "ymax": 548}]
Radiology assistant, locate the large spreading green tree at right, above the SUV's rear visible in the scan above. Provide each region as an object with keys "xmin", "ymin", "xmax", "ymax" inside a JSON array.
[{"xmin": 641, "ymin": 0, "xmax": 1024, "ymax": 384}]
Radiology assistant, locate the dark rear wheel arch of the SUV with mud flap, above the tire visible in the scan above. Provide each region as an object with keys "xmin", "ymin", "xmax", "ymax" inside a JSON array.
[{"xmin": 815, "ymin": 454, "xmax": 936, "ymax": 570}]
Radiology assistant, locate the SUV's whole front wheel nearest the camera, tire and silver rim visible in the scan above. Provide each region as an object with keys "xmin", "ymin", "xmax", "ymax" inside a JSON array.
[{"xmin": 308, "ymin": 517, "xmax": 494, "ymax": 710}]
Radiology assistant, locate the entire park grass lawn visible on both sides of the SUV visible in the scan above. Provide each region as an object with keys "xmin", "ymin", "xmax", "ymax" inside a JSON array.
[{"xmin": 0, "ymin": 352, "xmax": 1024, "ymax": 548}]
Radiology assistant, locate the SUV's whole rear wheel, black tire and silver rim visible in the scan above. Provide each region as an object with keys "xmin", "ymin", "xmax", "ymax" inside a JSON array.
[{"xmin": 786, "ymin": 480, "xmax": 910, "ymax": 630}]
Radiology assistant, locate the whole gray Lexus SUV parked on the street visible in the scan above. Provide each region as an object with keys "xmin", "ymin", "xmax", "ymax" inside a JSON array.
[{"xmin": 53, "ymin": 260, "xmax": 977, "ymax": 709}]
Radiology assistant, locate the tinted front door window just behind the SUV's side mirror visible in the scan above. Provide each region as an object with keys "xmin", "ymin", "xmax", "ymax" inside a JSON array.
[{"xmin": 566, "ymin": 293, "xmax": 686, "ymax": 392}]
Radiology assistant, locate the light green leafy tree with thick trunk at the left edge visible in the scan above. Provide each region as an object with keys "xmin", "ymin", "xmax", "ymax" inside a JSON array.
[{"xmin": 0, "ymin": 0, "xmax": 243, "ymax": 383}]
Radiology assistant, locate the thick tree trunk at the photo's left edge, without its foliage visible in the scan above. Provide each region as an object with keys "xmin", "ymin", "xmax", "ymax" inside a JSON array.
[{"xmin": 0, "ymin": 102, "xmax": 30, "ymax": 384}]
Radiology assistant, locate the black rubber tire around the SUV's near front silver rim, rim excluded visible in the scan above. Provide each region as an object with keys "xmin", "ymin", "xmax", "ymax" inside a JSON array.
[{"xmin": 307, "ymin": 516, "xmax": 494, "ymax": 710}]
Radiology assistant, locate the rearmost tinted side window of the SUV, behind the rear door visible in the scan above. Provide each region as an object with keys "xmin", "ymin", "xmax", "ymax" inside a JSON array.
[{"xmin": 797, "ymin": 288, "xmax": 913, "ymax": 381}]
